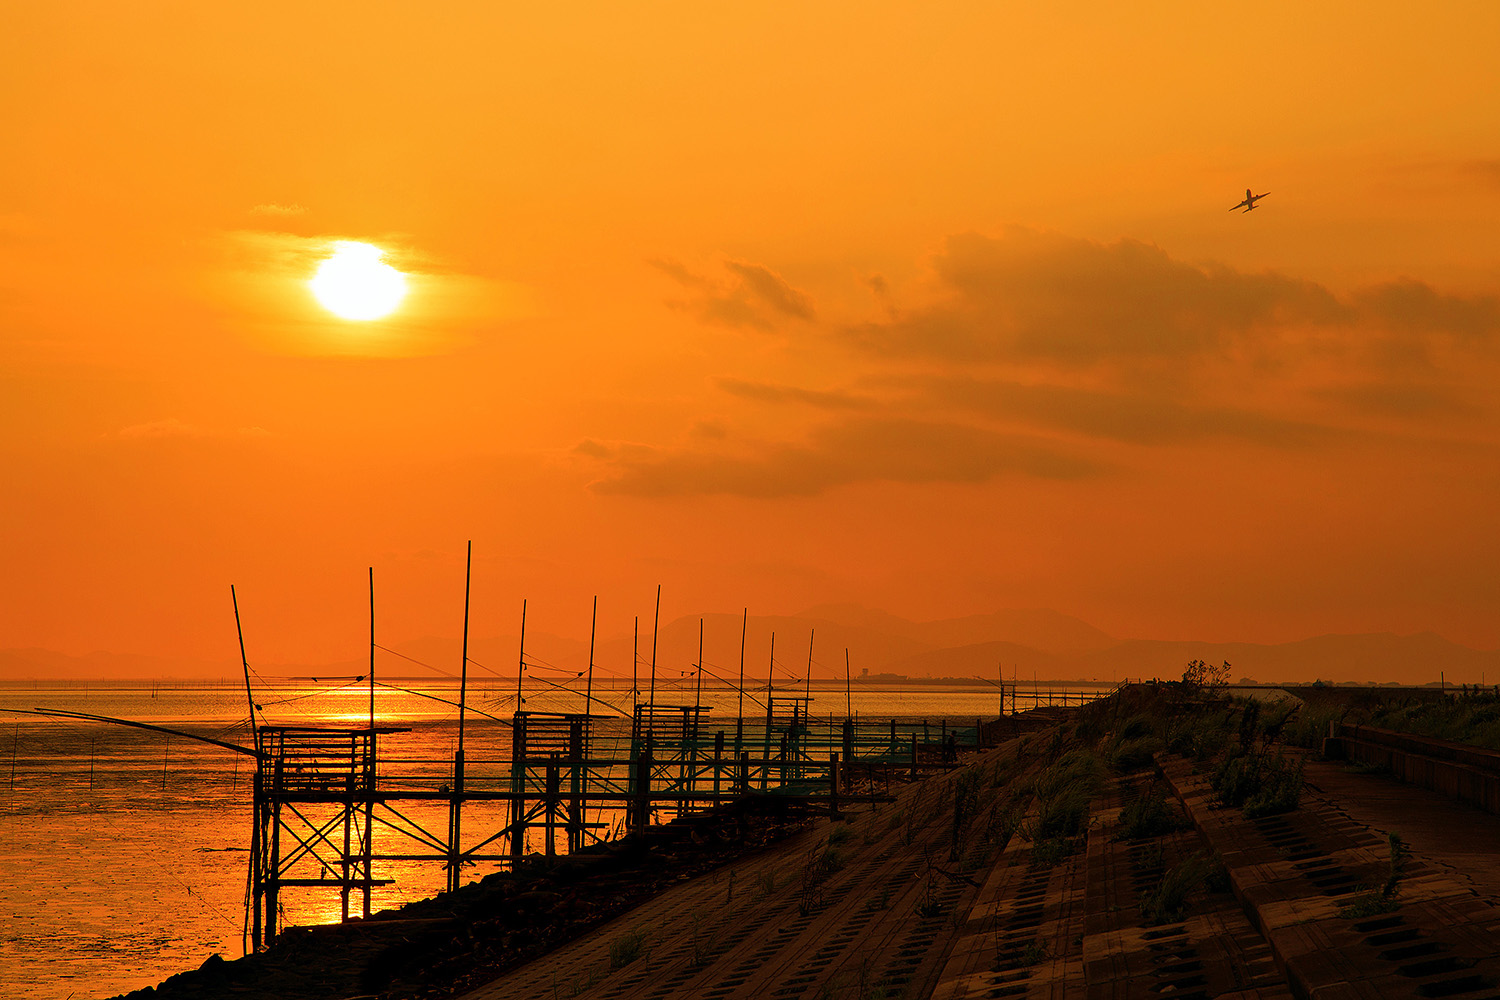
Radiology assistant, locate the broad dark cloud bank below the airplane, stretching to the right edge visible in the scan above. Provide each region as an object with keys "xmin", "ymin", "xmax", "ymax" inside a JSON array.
[{"xmin": 834, "ymin": 226, "xmax": 1500, "ymax": 419}]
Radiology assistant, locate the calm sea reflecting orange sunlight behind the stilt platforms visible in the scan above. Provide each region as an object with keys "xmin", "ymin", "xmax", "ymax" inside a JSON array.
[{"xmin": 0, "ymin": 681, "xmax": 1104, "ymax": 1000}]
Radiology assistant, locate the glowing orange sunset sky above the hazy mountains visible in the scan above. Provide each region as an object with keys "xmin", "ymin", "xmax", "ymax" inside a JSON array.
[{"xmin": 0, "ymin": 0, "xmax": 1500, "ymax": 661}]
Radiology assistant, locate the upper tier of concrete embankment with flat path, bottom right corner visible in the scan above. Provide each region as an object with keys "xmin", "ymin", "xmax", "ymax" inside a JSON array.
[{"xmin": 1166, "ymin": 759, "xmax": 1500, "ymax": 1000}]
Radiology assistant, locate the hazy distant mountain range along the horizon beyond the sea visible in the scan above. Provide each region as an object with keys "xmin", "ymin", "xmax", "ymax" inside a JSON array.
[{"xmin": 0, "ymin": 604, "xmax": 1500, "ymax": 690}]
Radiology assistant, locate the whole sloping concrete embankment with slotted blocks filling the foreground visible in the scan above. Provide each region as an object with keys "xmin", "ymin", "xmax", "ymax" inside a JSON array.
[{"xmin": 467, "ymin": 707, "xmax": 1500, "ymax": 1000}]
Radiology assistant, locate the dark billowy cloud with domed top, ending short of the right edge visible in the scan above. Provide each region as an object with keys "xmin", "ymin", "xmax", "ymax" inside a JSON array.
[{"xmin": 846, "ymin": 228, "xmax": 1349, "ymax": 366}]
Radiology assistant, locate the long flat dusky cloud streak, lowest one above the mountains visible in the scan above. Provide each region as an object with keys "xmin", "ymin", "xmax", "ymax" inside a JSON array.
[{"xmin": 593, "ymin": 418, "xmax": 1103, "ymax": 498}]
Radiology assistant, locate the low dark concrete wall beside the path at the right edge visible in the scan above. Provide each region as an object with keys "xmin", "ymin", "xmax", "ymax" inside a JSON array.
[{"xmin": 1323, "ymin": 724, "xmax": 1500, "ymax": 814}]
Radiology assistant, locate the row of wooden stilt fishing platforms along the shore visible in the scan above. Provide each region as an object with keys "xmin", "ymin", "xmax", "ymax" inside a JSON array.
[{"xmin": 251, "ymin": 697, "xmax": 999, "ymax": 948}]
